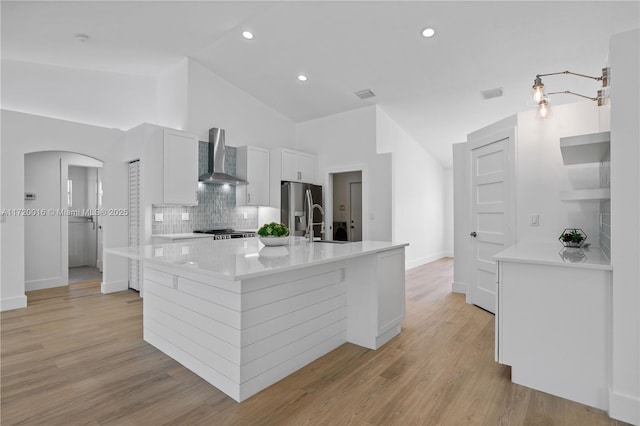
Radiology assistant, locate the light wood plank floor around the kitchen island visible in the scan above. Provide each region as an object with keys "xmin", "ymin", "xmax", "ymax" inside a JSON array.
[{"xmin": 0, "ymin": 259, "xmax": 620, "ymax": 426}]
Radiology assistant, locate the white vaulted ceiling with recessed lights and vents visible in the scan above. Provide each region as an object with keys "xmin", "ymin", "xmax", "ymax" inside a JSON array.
[{"xmin": 2, "ymin": 1, "xmax": 640, "ymax": 166}]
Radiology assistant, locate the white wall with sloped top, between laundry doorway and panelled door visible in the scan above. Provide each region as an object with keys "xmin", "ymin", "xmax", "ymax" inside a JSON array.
[{"xmin": 376, "ymin": 108, "xmax": 451, "ymax": 268}]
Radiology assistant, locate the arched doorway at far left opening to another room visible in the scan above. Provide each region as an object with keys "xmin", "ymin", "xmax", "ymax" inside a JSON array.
[{"xmin": 24, "ymin": 151, "xmax": 103, "ymax": 291}]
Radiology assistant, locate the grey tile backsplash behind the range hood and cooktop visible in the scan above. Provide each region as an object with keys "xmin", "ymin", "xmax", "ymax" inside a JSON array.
[{"xmin": 151, "ymin": 141, "xmax": 258, "ymax": 234}]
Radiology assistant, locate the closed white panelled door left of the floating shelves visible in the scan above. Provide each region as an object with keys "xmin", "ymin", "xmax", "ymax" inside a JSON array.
[{"xmin": 468, "ymin": 129, "xmax": 515, "ymax": 313}]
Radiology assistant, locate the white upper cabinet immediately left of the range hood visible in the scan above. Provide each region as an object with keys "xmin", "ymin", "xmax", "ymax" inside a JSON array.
[{"xmin": 163, "ymin": 130, "xmax": 198, "ymax": 205}]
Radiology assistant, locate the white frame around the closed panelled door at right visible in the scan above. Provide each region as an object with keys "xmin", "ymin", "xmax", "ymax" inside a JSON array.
[{"xmin": 466, "ymin": 126, "xmax": 518, "ymax": 306}]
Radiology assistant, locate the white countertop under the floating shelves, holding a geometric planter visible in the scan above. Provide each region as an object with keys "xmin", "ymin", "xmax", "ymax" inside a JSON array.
[{"xmin": 493, "ymin": 242, "xmax": 613, "ymax": 271}]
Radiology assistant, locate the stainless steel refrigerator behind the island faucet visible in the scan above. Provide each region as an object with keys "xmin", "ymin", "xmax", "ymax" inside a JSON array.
[{"xmin": 280, "ymin": 182, "xmax": 325, "ymax": 239}]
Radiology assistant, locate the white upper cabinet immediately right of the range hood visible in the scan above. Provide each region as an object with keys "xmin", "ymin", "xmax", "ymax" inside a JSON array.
[{"xmin": 236, "ymin": 146, "xmax": 269, "ymax": 206}]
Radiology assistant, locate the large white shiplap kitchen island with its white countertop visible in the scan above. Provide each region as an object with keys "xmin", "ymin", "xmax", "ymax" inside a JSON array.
[{"xmin": 105, "ymin": 237, "xmax": 407, "ymax": 401}]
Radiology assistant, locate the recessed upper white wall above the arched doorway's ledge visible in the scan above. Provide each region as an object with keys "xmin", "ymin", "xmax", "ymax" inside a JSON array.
[{"xmin": 2, "ymin": 59, "xmax": 156, "ymax": 129}]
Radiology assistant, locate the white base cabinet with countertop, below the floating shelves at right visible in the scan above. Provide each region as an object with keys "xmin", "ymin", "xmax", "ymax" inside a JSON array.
[{"xmin": 495, "ymin": 243, "xmax": 612, "ymax": 410}]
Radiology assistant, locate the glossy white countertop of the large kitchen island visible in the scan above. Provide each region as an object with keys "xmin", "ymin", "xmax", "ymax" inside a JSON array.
[{"xmin": 104, "ymin": 237, "xmax": 408, "ymax": 281}]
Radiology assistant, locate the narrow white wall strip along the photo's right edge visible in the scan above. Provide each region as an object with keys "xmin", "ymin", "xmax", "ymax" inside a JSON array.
[{"xmin": 609, "ymin": 29, "xmax": 640, "ymax": 425}]
